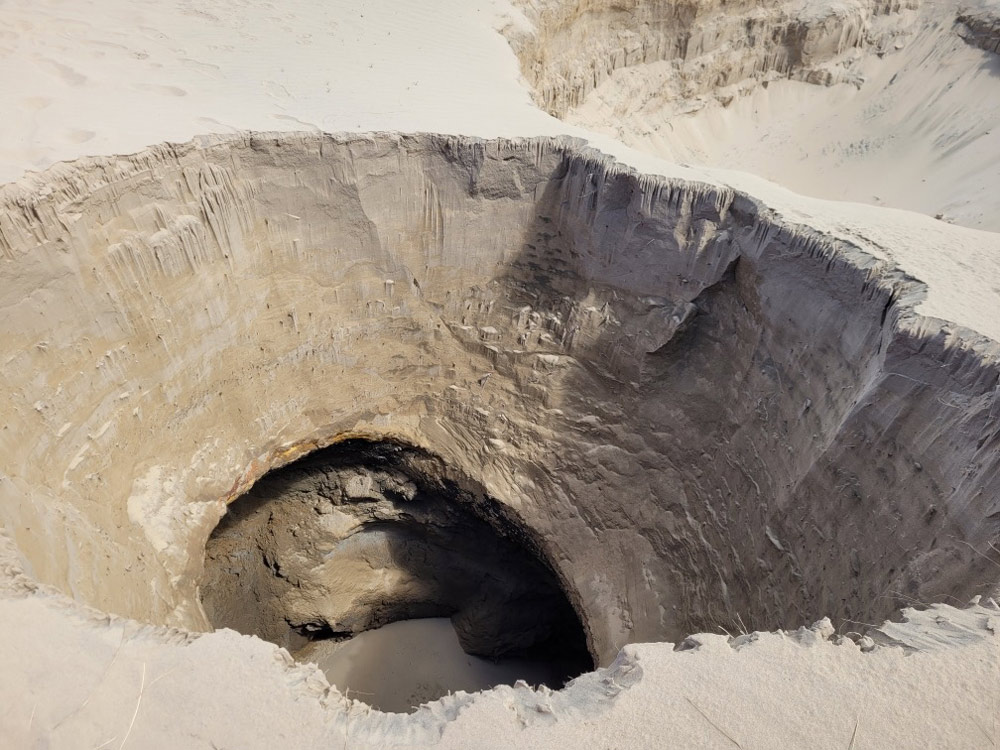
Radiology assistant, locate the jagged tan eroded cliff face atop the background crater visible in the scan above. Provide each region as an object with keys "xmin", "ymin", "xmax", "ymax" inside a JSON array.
[{"xmin": 506, "ymin": 0, "xmax": 916, "ymax": 117}]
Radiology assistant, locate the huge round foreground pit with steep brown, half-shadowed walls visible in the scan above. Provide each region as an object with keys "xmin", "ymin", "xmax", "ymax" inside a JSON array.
[{"xmin": 0, "ymin": 134, "xmax": 1000, "ymax": 680}]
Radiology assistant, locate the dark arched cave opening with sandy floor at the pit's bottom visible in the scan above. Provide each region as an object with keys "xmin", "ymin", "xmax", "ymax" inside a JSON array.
[{"xmin": 200, "ymin": 439, "xmax": 594, "ymax": 711}]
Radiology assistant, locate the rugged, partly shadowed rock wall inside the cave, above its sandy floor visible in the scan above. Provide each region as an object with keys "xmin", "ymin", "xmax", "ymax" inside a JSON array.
[{"xmin": 201, "ymin": 440, "xmax": 592, "ymax": 677}]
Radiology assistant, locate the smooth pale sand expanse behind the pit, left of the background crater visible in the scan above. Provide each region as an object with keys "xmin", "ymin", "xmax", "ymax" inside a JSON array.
[{"xmin": 0, "ymin": 0, "xmax": 552, "ymax": 182}]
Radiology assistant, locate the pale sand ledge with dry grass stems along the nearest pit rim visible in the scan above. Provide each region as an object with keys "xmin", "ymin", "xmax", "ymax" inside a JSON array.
[{"xmin": 0, "ymin": 596, "xmax": 1000, "ymax": 750}]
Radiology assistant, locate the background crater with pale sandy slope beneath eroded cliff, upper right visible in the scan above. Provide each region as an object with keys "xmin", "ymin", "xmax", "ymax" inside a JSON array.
[{"xmin": 505, "ymin": 0, "xmax": 1000, "ymax": 231}]
